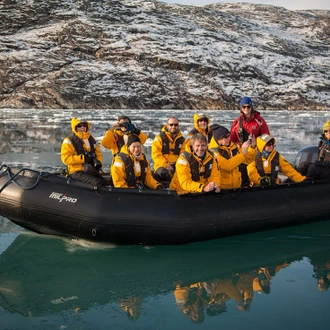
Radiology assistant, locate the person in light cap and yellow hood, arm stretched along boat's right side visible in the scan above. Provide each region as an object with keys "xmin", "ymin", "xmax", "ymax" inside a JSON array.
[{"xmin": 247, "ymin": 134, "xmax": 306, "ymax": 186}]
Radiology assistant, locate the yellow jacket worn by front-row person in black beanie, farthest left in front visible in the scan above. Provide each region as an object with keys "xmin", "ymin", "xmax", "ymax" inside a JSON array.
[{"xmin": 111, "ymin": 145, "xmax": 159, "ymax": 189}]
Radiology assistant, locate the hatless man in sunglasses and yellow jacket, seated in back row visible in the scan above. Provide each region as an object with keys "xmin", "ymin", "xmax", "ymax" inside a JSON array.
[{"xmin": 151, "ymin": 117, "xmax": 185, "ymax": 181}]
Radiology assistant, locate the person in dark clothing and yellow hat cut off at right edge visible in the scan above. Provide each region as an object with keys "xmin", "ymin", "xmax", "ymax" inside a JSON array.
[{"xmin": 306, "ymin": 120, "xmax": 330, "ymax": 180}]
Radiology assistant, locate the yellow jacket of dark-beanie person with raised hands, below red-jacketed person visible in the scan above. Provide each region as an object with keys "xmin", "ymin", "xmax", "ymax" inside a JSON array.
[{"xmin": 209, "ymin": 137, "xmax": 257, "ymax": 189}]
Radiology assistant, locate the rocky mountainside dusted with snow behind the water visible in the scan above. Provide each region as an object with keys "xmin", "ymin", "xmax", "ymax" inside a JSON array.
[{"xmin": 0, "ymin": 0, "xmax": 330, "ymax": 110}]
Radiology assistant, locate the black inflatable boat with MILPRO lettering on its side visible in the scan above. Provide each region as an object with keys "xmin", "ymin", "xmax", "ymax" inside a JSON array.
[{"xmin": 0, "ymin": 148, "xmax": 330, "ymax": 245}]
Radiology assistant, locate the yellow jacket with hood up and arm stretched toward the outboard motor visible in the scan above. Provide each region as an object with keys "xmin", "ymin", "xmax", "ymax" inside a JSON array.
[{"xmin": 247, "ymin": 137, "xmax": 306, "ymax": 185}]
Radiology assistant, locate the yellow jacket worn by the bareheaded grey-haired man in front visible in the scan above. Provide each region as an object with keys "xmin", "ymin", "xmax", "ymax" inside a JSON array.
[{"xmin": 170, "ymin": 145, "xmax": 221, "ymax": 194}]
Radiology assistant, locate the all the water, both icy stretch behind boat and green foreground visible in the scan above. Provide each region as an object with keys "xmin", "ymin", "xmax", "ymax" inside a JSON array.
[{"xmin": 0, "ymin": 110, "xmax": 330, "ymax": 329}]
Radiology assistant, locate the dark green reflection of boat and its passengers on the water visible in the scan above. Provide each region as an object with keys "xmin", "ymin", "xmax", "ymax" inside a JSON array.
[{"xmin": 0, "ymin": 222, "xmax": 330, "ymax": 323}]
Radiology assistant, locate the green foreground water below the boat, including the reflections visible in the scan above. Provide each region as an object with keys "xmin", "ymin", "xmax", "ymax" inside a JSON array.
[{"xmin": 0, "ymin": 218, "xmax": 330, "ymax": 329}]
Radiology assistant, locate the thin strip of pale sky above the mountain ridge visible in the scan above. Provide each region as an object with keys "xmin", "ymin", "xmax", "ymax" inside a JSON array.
[{"xmin": 159, "ymin": 0, "xmax": 330, "ymax": 10}]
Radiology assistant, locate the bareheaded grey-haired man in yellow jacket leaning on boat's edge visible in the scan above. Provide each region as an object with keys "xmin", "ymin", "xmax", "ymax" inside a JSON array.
[{"xmin": 170, "ymin": 133, "xmax": 220, "ymax": 194}]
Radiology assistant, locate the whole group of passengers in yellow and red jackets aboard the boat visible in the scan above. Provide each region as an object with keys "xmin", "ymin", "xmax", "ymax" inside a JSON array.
[{"xmin": 61, "ymin": 96, "xmax": 330, "ymax": 194}]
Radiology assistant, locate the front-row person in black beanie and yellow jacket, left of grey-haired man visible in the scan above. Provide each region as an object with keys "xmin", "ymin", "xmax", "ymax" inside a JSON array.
[{"xmin": 111, "ymin": 134, "xmax": 164, "ymax": 190}]
